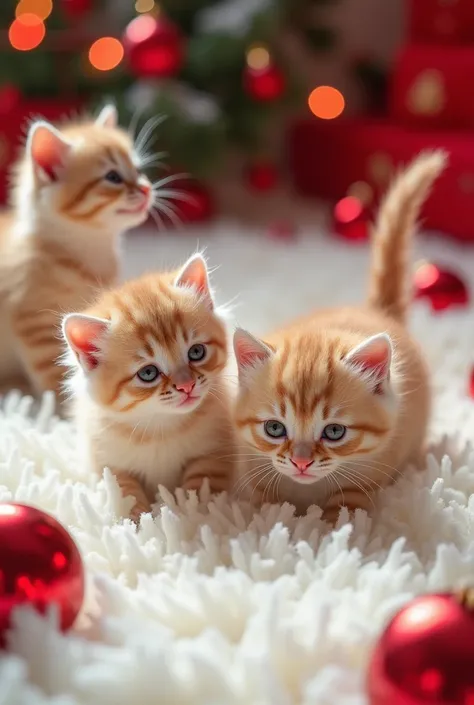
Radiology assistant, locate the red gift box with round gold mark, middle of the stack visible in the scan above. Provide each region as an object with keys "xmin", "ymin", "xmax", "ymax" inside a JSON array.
[{"xmin": 390, "ymin": 45, "xmax": 474, "ymax": 129}]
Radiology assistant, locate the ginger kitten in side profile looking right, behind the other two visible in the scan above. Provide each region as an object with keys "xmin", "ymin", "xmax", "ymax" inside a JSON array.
[{"xmin": 0, "ymin": 106, "xmax": 153, "ymax": 392}]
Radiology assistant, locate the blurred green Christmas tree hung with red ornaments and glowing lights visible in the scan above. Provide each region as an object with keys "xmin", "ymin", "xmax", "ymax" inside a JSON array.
[{"xmin": 0, "ymin": 0, "xmax": 342, "ymax": 182}]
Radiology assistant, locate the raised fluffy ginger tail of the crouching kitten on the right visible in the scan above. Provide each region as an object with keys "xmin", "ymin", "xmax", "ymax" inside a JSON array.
[{"xmin": 369, "ymin": 151, "xmax": 447, "ymax": 322}]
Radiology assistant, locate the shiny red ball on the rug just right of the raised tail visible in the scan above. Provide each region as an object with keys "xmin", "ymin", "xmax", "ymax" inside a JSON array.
[{"xmin": 414, "ymin": 262, "xmax": 469, "ymax": 311}]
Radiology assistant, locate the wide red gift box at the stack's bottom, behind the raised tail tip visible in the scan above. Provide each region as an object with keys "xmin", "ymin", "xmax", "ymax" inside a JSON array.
[{"xmin": 289, "ymin": 119, "xmax": 474, "ymax": 242}]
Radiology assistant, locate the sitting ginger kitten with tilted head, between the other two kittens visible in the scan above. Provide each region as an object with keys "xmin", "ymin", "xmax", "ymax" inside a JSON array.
[{"xmin": 63, "ymin": 255, "xmax": 232, "ymax": 519}]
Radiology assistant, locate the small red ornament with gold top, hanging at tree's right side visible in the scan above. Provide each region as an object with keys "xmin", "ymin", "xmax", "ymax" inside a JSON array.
[{"xmin": 243, "ymin": 46, "xmax": 286, "ymax": 102}]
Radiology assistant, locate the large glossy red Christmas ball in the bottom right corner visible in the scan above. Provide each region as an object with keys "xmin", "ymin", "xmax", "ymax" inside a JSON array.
[{"xmin": 367, "ymin": 590, "xmax": 474, "ymax": 705}]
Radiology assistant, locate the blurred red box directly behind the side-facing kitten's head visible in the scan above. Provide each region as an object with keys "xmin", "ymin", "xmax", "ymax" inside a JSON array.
[{"xmin": 0, "ymin": 100, "xmax": 82, "ymax": 204}]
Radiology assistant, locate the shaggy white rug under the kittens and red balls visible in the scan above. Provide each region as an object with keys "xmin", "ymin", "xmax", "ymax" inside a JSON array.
[{"xmin": 0, "ymin": 225, "xmax": 474, "ymax": 705}]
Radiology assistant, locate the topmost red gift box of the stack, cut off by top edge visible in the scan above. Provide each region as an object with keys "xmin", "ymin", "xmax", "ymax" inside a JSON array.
[{"xmin": 409, "ymin": 0, "xmax": 474, "ymax": 44}]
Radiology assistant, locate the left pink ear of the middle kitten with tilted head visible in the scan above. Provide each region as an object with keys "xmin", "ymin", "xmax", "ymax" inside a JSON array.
[{"xmin": 63, "ymin": 313, "xmax": 110, "ymax": 372}]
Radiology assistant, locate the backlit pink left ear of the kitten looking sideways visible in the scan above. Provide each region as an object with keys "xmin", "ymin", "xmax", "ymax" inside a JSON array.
[{"xmin": 26, "ymin": 120, "xmax": 72, "ymax": 181}]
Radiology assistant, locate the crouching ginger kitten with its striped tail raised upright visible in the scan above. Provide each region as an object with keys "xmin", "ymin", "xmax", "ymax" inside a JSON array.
[{"xmin": 234, "ymin": 152, "xmax": 446, "ymax": 521}]
